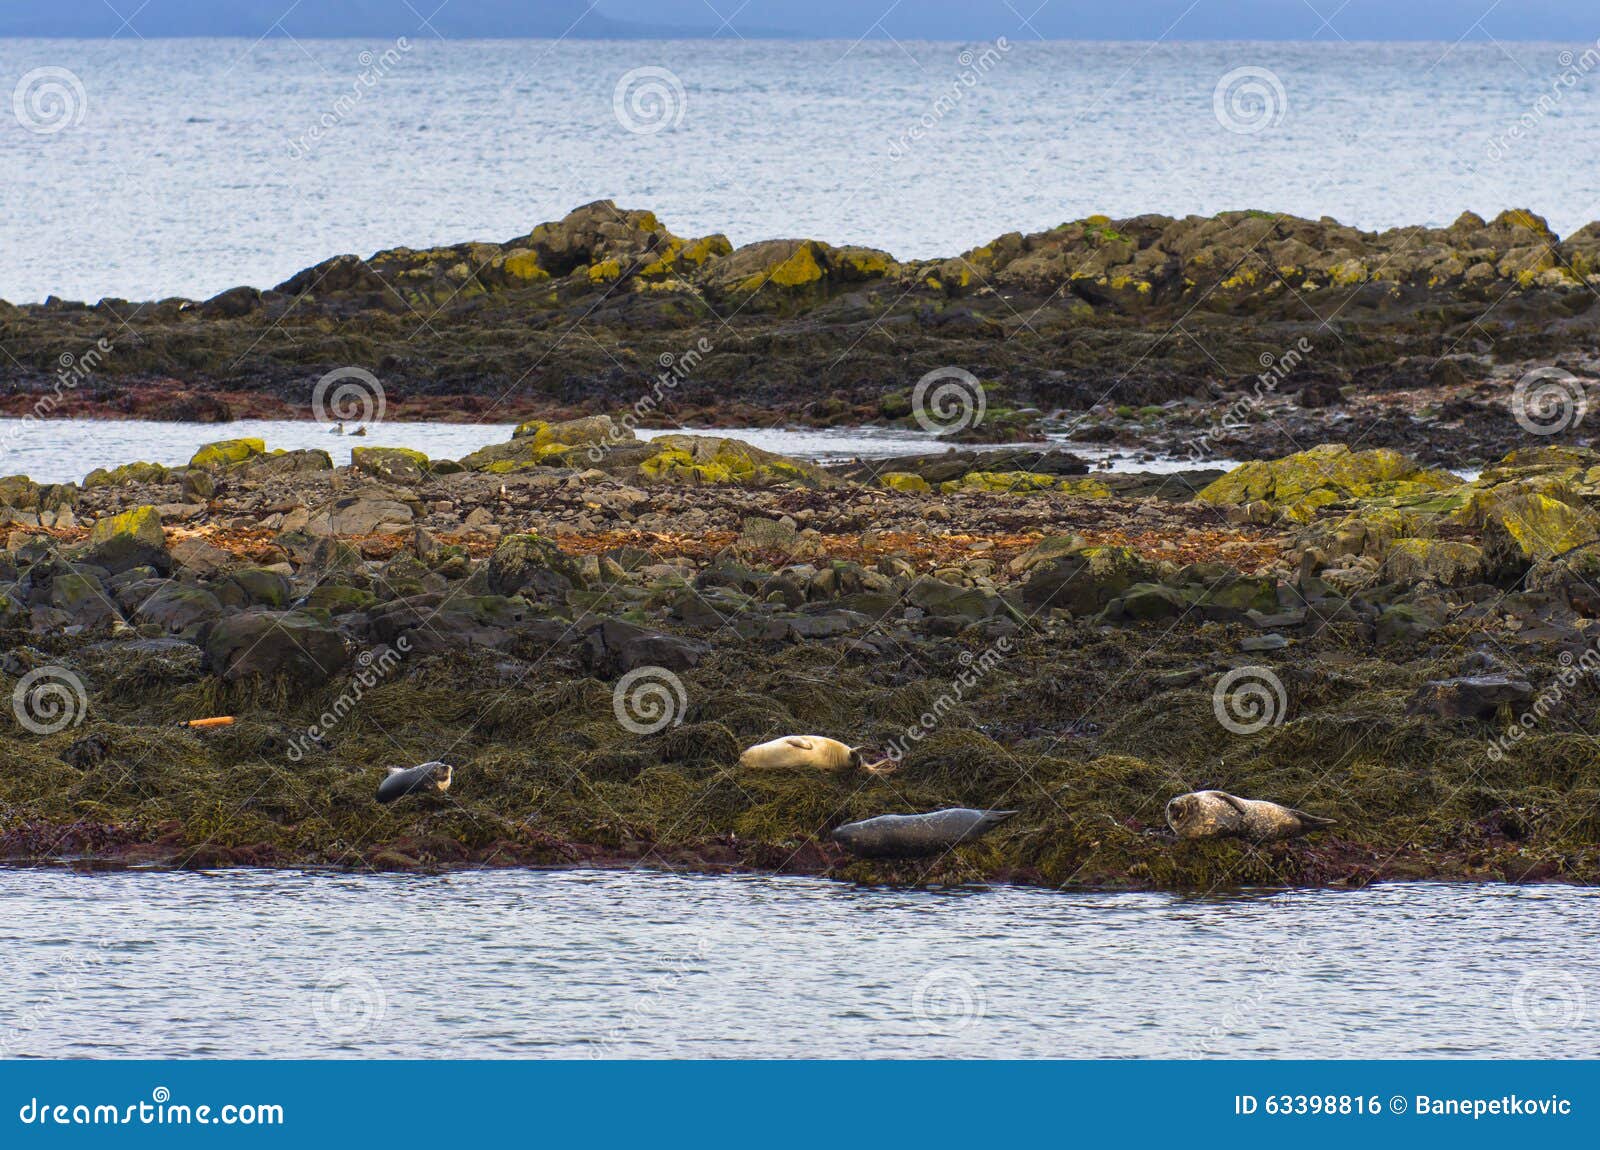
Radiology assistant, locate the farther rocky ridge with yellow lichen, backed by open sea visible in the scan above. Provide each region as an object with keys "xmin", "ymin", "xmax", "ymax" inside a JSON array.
[{"xmin": 9, "ymin": 202, "xmax": 1600, "ymax": 467}]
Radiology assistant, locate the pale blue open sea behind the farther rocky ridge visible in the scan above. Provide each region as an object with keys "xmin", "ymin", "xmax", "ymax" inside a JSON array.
[{"xmin": 0, "ymin": 35, "xmax": 1600, "ymax": 302}]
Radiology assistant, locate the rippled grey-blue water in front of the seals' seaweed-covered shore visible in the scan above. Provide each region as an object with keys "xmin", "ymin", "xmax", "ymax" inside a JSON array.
[{"xmin": 0, "ymin": 870, "xmax": 1600, "ymax": 1057}]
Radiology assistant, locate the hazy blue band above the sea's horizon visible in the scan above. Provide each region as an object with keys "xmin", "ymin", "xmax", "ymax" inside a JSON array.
[{"xmin": 0, "ymin": 0, "xmax": 1600, "ymax": 43}]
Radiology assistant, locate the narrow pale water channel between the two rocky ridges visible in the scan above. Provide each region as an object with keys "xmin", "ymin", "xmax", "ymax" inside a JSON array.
[{"xmin": 0, "ymin": 419, "xmax": 1232, "ymax": 483}]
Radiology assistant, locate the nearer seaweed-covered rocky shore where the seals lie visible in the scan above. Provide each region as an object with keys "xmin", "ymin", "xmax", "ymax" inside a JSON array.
[{"xmin": 0, "ymin": 419, "xmax": 1600, "ymax": 891}]
